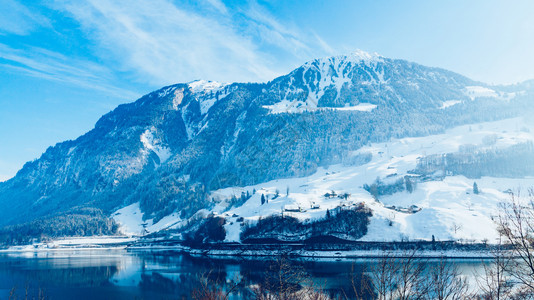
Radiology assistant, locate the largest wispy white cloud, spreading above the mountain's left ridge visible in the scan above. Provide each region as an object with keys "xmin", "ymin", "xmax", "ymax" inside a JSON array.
[{"xmin": 52, "ymin": 0, "xmax": 332, "ymax": 85}]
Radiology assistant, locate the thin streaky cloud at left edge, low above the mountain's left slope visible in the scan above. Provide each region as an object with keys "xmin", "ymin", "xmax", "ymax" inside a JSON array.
[{"xmin": 0, "ymin": 44, "xmax": 139, "ymax": 100}]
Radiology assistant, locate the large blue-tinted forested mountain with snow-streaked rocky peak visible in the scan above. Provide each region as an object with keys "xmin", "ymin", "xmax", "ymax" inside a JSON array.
[{"xmin": 0, "ymin": 51, "xmax": 532, "ymax": 244}]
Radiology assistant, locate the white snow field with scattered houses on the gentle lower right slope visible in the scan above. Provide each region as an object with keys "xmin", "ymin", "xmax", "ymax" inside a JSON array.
[{"xmin": 210, "ymin": 118, "xmax": 534, "ymax": 242}]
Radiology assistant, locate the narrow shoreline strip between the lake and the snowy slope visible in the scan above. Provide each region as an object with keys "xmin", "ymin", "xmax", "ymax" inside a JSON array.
[{"xmin": 0, "ymin": 236, "xmax": 502, "ymax": 260}]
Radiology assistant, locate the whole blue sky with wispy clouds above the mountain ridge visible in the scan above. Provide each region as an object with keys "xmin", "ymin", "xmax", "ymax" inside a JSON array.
[{"xmin": 0, "ymin": 0, "xmax": 534, "ymax": 181}]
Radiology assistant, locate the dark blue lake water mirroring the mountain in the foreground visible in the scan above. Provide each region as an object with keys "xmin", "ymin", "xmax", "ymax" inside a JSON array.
[{"xmin": 0, "ymin": 250, "xmax": 490, "ymax": 300}]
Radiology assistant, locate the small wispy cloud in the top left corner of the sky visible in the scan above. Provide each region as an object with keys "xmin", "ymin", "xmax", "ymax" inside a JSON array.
[{"xmin": 0, "ymin": 0, "xmax": 50, "ymax": 35}]
